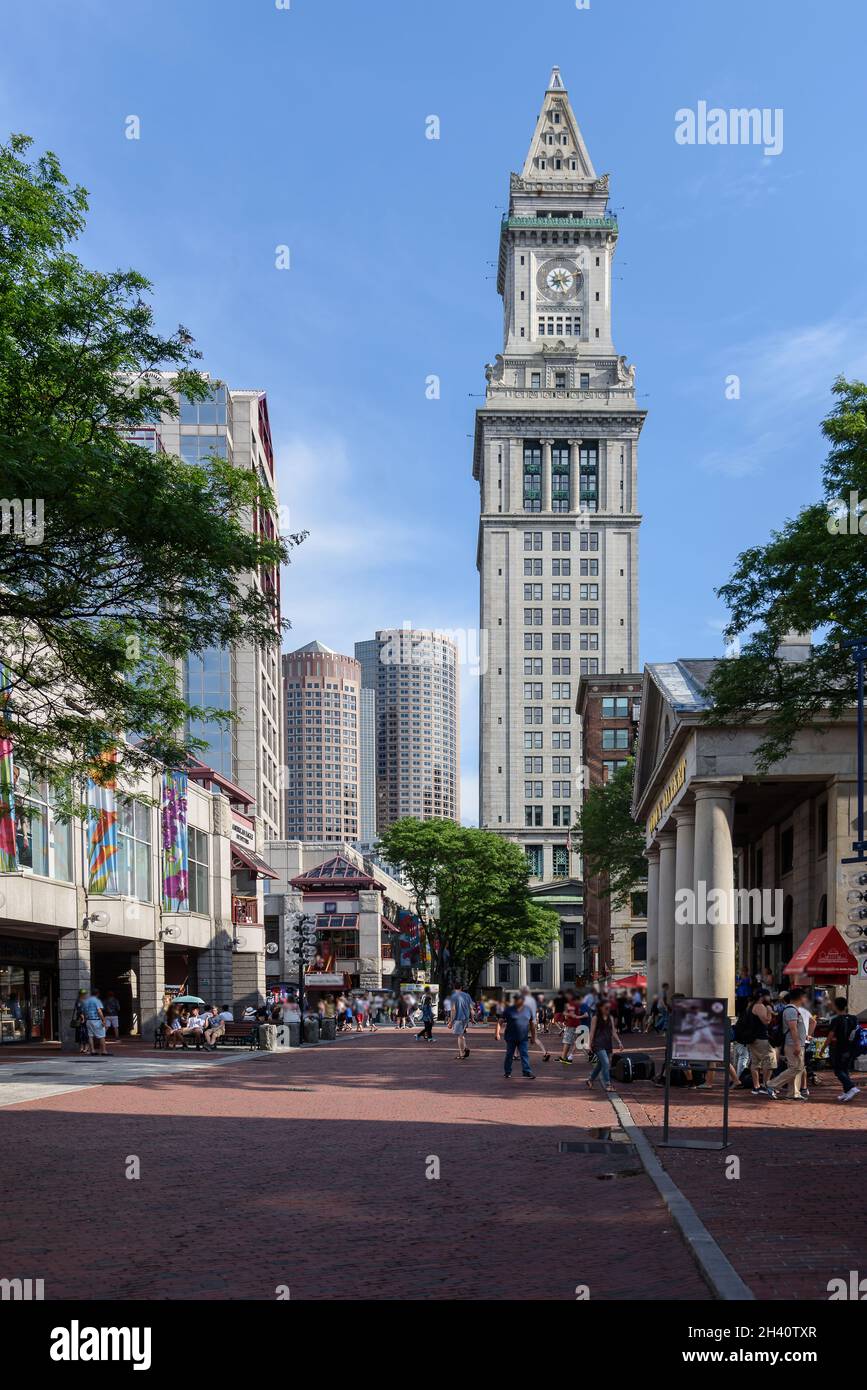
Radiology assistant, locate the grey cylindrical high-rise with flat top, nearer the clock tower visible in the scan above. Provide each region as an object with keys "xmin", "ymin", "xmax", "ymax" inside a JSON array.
[{"xmin": 356, "ymin": 628, "xmax": 460, "ymax": 834}]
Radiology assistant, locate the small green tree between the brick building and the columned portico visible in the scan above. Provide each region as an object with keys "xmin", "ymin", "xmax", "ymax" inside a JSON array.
[{"xmin": 572, "ymin": 758, "xmax": 647, "ymax": 908}]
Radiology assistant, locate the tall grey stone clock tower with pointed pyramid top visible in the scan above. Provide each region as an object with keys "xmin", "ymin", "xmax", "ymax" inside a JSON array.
[{"xmin": 472, "ymin": 68, "xmax": 645, "ymax": 988}]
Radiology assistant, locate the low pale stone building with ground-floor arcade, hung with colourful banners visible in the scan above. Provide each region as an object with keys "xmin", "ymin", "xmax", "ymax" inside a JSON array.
[{"xmin": 0, "ymin": 763, "xmax": 272, "ymax": 1048}]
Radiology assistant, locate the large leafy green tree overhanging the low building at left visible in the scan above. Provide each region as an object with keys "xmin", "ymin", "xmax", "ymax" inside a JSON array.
[{"xmin": 0, "ymin": 136, "xmax": 302, "ymax": 800}]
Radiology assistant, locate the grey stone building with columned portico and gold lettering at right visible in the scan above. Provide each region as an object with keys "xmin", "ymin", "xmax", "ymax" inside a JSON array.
[{"xmin": 634, "ymin": 641, "xmax": 867, "ymax": 1013}]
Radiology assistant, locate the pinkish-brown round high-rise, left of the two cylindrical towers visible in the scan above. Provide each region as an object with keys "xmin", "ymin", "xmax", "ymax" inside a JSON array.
[{"xmin": 283, "ymin": 642, "xmax": 361, "ymax": 842}]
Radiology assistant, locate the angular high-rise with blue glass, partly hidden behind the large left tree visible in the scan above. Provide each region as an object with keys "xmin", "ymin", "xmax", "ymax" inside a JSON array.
[{"xmin": 149, "ymin": 374, "xmax": 283, "ymax": 838}]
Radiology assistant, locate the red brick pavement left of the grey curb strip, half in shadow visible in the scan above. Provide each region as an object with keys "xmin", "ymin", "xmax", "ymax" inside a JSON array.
[{"xmin": 0, "ymin": 1029, "xmax": 711, "ymax": 1301}]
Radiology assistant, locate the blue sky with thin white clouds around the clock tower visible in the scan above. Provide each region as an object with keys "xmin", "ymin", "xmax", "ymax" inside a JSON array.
[{"xmin": 0, "ymin": 0, "xmax": 867, "ymax": 820}]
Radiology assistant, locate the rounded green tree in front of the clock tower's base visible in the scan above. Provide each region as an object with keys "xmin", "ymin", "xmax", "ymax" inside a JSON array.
[{"xmin": 379, "ymin": 817, "xmax": 560, "ymax": 988}]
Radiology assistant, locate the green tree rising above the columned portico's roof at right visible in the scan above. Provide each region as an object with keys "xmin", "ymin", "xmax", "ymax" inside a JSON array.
[{"xmin": 704, "ymin": 377, "xmax": 867, "ymax": 771}]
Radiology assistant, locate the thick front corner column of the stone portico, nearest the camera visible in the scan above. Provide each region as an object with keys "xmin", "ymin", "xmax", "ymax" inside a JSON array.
[{"xmin": 692, "ymin": 781, "xmax": 735, "ymax": 1013}]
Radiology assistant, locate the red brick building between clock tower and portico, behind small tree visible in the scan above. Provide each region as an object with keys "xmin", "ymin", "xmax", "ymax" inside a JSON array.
[{"xmin": 575, "ymin": 673, "xmax": 647, "ymax": 980}]
